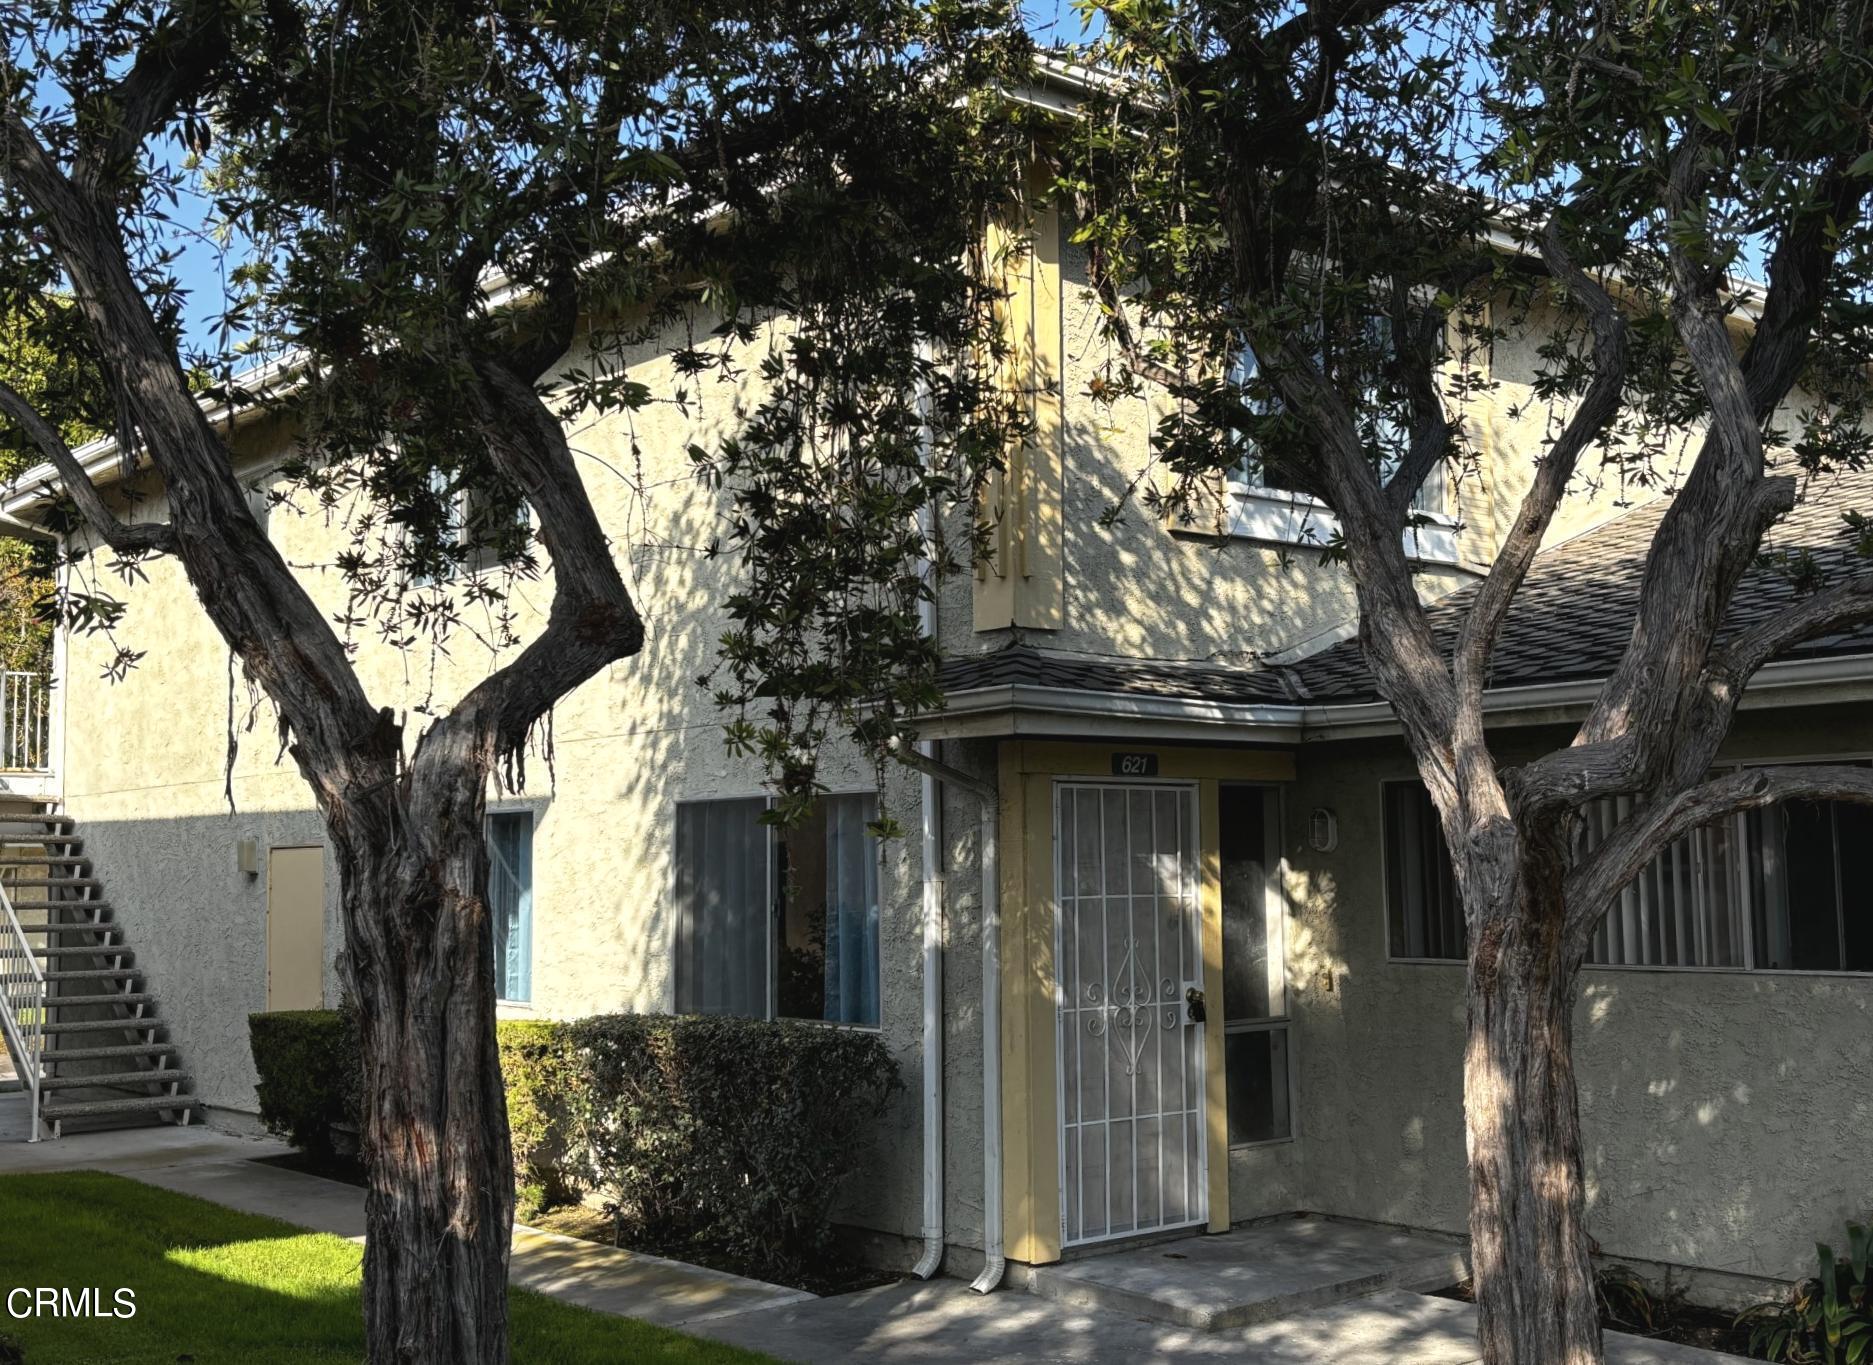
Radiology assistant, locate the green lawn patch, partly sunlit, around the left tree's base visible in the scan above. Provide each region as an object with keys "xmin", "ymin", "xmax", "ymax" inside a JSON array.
[{"xmin": 0, "ymin": 1172, "xmax": 782, "ymax": 1365}]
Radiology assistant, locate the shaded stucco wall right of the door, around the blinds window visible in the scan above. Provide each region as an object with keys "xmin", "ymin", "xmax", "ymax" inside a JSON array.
[{"xmin": 1287, "ymin": 708, "xmax": 1873, "ymax": 1277}]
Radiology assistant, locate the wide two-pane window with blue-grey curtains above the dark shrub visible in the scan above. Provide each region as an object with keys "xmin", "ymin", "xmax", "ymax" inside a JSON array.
[{"xmin": 676, "ymin": 794, "xmax": 878, "ymax": 1028}]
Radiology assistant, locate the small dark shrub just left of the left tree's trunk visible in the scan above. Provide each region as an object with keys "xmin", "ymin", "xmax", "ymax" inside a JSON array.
[{"xmin": 247, "ymin": 1009, "xmax": 363, "ymax": 1157}]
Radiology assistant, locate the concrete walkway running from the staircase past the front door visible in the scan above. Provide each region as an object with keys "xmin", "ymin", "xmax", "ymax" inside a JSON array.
[{"xmin": 0, "ymin": 1095, "xmax": 1734, "ymax": 1365}]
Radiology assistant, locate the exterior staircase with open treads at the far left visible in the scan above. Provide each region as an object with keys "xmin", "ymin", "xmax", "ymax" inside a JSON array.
[{"xmin": 0, "ymin": 813, "xmax": 197, "ymax": 1140}]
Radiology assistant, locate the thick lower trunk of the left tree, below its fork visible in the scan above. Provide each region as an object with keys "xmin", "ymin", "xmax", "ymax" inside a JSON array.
[{"xmin": 335, "ymin": 797, "xmax": 513, "ymax": 1365}]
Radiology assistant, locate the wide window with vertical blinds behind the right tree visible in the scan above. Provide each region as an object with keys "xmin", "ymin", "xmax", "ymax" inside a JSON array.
[{"xmin": 1384, "ymin": 783, "xmax": 1873, "ymax": 972}]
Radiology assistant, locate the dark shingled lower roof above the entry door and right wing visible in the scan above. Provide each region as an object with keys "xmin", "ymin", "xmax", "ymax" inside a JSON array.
[{"xmin": 942, "ymin": 470, "xmax": 1873, "ymax": 728}]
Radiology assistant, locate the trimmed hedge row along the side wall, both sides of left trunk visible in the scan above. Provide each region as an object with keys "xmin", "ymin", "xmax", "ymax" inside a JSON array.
[{"xmin": 249, "ymin": 1009, "xmax": 901, "ymax": 1275}]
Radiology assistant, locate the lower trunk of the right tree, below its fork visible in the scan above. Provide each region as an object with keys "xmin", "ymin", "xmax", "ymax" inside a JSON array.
[{"xmin": 1463, "ymin": 871, "xmax": 1601, "ymax": 1365}]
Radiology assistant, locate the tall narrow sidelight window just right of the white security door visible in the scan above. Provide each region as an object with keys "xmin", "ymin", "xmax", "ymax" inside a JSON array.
[{"xmin": 1217, "ymin": 783, "xmax": 1294, "ymax": 1146}]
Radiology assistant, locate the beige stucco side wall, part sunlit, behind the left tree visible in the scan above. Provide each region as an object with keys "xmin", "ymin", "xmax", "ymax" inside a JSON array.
[{"xmin": 64, "ymin": 314, "xmax": 993, "ymax": 1245}]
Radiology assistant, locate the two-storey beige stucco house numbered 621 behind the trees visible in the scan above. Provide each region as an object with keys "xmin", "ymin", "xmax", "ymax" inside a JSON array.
[{"xmin": 0, "ymin": 144, "xmax": 1873, "ymax": 1303}]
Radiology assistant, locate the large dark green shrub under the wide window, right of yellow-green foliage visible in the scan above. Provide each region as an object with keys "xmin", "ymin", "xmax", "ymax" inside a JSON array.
[{"xmin": 569, "ymin": 1015, "xmax": 899, "ymax": 1273}]
